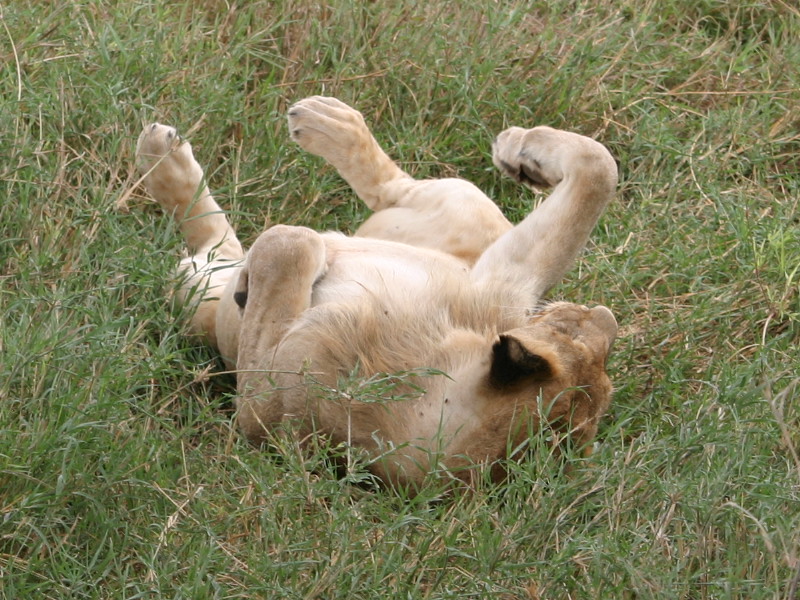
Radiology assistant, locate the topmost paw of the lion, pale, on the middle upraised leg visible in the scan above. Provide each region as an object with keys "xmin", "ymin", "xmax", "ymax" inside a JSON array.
[{"xmin": 289, "ymin": 96, "xmax": 372, "ymax": 167}]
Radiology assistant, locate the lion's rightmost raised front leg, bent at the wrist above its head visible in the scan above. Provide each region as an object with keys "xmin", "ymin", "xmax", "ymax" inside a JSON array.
[{"xmin": 472, "ymin": 127, "xmax": 617, "ymax": 305}]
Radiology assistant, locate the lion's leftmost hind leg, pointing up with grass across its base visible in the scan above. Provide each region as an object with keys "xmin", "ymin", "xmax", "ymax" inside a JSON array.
[{"xmin": 136, "ymin": 123, "xmax": 244, "ymax": 347}]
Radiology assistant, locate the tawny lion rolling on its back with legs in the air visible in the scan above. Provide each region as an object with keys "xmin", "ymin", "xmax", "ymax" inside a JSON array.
[{"xmin": 137, "ymin": 97, "xmax": 617, "ymax": 487}]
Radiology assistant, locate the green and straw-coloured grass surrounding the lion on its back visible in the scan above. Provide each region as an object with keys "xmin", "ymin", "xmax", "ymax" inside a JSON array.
[{"xmin": 0, "ymin": 0, "xmax": 800, "ymax": 600}]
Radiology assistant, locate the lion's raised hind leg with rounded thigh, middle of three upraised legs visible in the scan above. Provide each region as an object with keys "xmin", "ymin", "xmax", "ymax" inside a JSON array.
[{"xmin": 289, "ymin": 96, "xmax": 511, "ymax": 265}]
